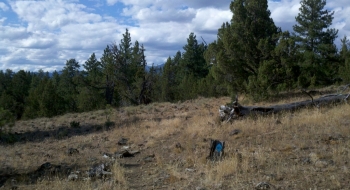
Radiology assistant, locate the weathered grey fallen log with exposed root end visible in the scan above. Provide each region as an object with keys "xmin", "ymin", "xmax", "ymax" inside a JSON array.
[{"xmin": 219, "ymin": 91, "xmax": 350, "ymax": 122}]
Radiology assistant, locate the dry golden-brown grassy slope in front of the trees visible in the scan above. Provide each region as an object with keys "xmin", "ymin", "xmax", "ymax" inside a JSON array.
[{"xmin": 0, "ymin": 96, "xmax": 350, "ymax": 190}]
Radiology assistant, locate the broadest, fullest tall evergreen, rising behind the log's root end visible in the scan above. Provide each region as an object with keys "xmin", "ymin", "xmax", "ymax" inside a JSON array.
[{"xmin": 206, "ymin": 0, "xmax": 280, "ymax": 95}]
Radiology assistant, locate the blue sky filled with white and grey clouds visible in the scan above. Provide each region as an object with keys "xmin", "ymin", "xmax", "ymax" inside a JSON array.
[{"xmin": 0, "ymin": 0, "xmax": 350, "ymax": 71}]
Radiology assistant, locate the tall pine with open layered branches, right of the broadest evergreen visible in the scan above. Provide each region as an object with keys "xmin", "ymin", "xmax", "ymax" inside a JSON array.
[{"xmin": 293, "ymin": 0, "xmax": 338, "ymax": 87}]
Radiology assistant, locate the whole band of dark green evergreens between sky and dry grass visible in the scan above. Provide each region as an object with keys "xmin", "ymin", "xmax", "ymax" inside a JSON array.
[{"xmin": 0, "ymin": 0, "xmax": 350, "ymax": 120}]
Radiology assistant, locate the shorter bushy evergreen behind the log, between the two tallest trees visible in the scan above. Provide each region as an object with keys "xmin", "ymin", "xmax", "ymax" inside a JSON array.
[{"xmin": 247, "ymin": 32, "xmax": 300, "ymax": 100}]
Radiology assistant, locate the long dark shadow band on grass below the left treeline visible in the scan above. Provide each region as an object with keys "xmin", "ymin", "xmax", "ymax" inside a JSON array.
[{"xmin": 0, "ymin": 117, "xmax": 139, "ymax": 145}]
